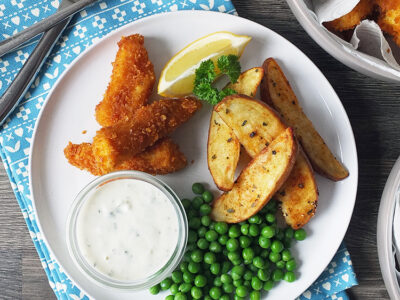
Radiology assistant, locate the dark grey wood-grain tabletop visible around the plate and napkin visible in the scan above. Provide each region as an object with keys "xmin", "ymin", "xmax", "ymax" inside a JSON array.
[{"xmin": 0, "ymin": 0, "xmax": 400, "ymax": 300}]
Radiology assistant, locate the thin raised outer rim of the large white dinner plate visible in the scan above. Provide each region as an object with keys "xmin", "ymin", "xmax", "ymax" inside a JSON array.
[{"xmin": 28, "ymin": 10, "xmax": 358, "ymax": 298}]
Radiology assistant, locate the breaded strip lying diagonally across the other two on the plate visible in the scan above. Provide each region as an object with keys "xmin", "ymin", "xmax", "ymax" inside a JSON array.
[{"xmin": 93, "ymin": 97, "xmax": 201, "ymax": 170}]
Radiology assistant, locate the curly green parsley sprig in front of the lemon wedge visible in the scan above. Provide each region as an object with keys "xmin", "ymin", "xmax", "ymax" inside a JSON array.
[{"xmin": 193, "ymin": 54, "xmax": 240, "ymax": 105}]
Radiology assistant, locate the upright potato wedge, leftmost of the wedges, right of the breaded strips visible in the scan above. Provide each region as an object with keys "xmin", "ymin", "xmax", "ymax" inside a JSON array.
[{"xmin": 207, "ymin": 111, "xmax": 240, "ymax": 191}]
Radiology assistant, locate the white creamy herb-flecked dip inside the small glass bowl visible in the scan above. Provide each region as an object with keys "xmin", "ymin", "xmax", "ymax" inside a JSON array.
[{"xmin": 76, "ymin": 179, "xmax": 178, "ymax": 281}]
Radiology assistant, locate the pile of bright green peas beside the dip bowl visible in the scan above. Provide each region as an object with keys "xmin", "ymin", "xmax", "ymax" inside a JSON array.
[{"xmin": 150, "ymin": 183, "xmax": 307, "ymax": 300}]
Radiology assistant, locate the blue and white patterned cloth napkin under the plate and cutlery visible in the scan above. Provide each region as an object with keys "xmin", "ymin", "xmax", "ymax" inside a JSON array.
[{"xmin": 0, "ymin": 0, "xmax": 357, "ymax": 300}]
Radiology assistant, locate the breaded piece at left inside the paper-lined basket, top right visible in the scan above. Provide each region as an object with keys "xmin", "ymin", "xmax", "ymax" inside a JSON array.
[{"xmin": 324, "ymin": 0, "xmax": 374, "ymax": 31}]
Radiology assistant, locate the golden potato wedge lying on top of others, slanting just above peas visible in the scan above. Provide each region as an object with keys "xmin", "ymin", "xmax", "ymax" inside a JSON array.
[{"xmin": 211, "ymin": 128, "xmax": 297, "ymax": 223}]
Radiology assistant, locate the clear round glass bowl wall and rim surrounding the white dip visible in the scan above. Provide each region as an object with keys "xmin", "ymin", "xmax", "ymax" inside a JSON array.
[{"xmin": 67, "ymin": 171, "xmax": 188, "ymax": 290}]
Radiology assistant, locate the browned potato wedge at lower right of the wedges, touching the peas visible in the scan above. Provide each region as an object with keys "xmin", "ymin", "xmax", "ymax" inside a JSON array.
[{"xmin": 274, "ymin": 148, "xmax": 318, "ymax": 229}]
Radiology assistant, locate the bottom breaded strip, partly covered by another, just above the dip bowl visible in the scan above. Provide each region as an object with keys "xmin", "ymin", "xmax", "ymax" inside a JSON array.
[{"xmin": 64, "ymin": 138, "xmax": 187, "ymax": 176}]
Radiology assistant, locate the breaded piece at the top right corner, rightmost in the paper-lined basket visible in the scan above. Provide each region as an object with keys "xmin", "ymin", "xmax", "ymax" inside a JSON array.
[{"xmin": 377, "ymin": 0, "xmax": 400, "ymax": 46}]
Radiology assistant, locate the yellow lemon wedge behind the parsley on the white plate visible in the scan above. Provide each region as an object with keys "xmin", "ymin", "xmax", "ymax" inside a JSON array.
[{"xmin": 158, "ymin": 31, "xmax": 251, "ymax": 97}]
